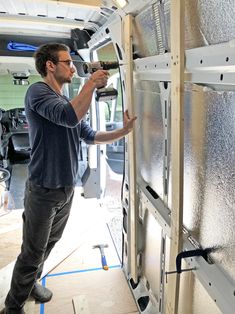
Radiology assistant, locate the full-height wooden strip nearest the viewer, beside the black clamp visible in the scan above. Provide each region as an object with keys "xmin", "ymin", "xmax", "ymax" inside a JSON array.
[{"xmin": 166, "ymin": 0, "xmax": 185, "ymax": 314}]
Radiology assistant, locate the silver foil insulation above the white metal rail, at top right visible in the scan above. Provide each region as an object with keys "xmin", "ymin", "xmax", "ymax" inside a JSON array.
[{"xmin": 134, "ymin": 0, "xmax": 235, "ymax": 57}]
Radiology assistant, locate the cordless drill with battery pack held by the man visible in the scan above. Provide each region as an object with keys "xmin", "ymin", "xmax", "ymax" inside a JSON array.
[{"xmin": 83, "ymin": 61, "xmax": 119, "ymax": 101}]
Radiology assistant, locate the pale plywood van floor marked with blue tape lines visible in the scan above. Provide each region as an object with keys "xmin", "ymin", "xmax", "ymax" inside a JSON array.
[{"xmin": 0, "ymin": 191, "xmax": 138, "ymax": 314}]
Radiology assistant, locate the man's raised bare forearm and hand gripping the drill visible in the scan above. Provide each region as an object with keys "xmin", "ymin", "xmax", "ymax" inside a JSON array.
[{"xmin": 70, "ymin": 70, "xmax": 109, "ymax": 121}]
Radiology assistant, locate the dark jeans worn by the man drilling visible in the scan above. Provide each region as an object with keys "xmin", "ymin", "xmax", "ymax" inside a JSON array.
[{"xmin": 5, "ymin": 181, "xmax": 74, "ymax": 309}]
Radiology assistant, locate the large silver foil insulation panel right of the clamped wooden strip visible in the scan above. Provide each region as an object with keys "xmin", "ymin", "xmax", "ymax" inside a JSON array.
[{"xmin": 169, "ymin": 84, "xmax": 235, "ymax": 279}]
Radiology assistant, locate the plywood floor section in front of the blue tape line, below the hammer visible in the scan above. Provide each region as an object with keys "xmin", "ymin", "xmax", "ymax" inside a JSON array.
[{"xmin": 45, "ymin": 269, "xmax": 138, "ymax": 314}]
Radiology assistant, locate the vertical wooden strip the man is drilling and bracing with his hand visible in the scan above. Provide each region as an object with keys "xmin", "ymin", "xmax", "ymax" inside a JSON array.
[{"xmin": 123, "ymin": 15, "xmax": 138, "ymax": 282}]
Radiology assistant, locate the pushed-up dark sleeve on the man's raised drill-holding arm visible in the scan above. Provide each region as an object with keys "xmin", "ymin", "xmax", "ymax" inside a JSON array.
[{"xmin": 25, "ymin": 82, "xmax": 79, "ymax": 128}]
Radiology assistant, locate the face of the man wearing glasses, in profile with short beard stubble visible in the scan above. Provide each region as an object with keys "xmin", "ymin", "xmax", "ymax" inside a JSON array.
[{"xmin": 54, "ymin": 51, "xmax": 76, "ymax": 84}]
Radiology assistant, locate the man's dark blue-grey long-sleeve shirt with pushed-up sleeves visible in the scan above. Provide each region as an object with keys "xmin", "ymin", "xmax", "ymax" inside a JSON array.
[{"xmin": 25, "ymin": 82, "xmax": 96, "ymax": 189}]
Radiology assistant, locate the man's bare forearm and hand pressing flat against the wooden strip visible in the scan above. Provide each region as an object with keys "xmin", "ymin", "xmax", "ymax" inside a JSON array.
[{"xmin": 95, "ymin": 110, "xmax": 136, "ymax": 144}]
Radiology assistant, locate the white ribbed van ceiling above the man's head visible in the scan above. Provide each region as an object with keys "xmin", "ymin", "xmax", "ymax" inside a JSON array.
[{"xmin": 0, "ymin": 0, "xmax": 116, "ymax": 37}]
